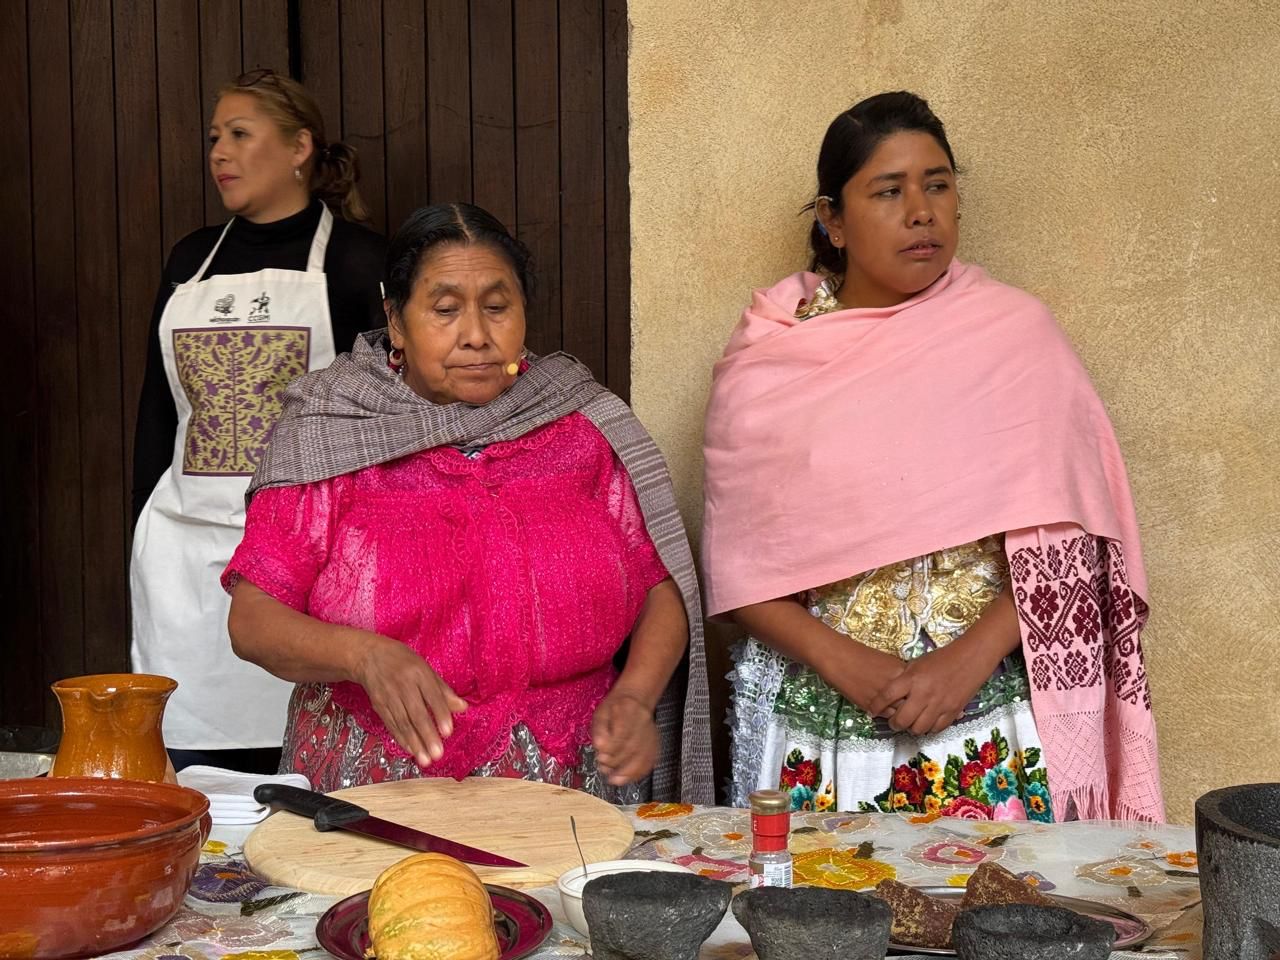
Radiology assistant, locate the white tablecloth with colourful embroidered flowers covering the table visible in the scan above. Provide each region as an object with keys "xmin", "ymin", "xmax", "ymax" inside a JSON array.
[{"xmin": 110, "ymin": 804, "xmax": 1201, "ymax": 960}]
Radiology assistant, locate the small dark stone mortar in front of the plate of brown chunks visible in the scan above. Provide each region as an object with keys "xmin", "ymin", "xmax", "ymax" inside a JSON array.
[{"xmin": 951, "ymin": 904, "xmax": 1116, "ymax": 960}]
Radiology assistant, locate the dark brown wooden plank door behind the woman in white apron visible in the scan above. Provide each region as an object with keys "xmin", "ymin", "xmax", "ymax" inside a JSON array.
[{"xmin": 0, "ymin": 0, "xmax": 630, "ymax": 726}]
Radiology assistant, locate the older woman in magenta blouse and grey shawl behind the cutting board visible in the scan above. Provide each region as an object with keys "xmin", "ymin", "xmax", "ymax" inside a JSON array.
[{"xmin": 223, "ymin": 204, "xmax": 710, "ymax": 801}]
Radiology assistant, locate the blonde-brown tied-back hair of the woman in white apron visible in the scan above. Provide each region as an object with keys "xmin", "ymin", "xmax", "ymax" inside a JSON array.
[{"xmin": 218, "ymin": 69, "xmax": 369, "ymax": 223}]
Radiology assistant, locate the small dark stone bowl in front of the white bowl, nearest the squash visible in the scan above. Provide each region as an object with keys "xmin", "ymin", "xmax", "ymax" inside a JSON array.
[{"xmin": 582, "ymin": 872, "xmax": 733, "ymax": 960}]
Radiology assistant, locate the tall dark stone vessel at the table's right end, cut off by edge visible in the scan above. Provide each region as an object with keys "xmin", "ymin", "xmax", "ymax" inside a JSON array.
[{"xmin": 1196, "ymin": 783, "xmax": 1280, "ymax": 960}]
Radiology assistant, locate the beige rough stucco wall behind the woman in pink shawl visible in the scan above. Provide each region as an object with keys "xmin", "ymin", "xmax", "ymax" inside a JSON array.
[{"xmin": 628, "ymin": 0, "xmax": 1280, "ymax": 822}]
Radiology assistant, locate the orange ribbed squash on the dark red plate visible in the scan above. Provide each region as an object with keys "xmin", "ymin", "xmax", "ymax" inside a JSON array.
[{"xmin": 369, "ymin": 854, "xmax": 500, "ymax": 960}]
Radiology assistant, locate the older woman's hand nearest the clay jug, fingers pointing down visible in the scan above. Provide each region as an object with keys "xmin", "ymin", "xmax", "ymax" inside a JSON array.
[{"xmin": 352, "ymin": 634, "xmax": 467, "ymax": 768}]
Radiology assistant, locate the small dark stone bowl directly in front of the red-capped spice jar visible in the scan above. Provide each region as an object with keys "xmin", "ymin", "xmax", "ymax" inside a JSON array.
[{"xmin": 733, "ymin": 887, "xmax": 892, "ymax": 960}]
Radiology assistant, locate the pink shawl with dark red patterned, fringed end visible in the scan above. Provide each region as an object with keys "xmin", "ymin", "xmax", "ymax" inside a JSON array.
[{"xmin": 703, "ymin": 261, "xmax": 1164, "ymax": 820}]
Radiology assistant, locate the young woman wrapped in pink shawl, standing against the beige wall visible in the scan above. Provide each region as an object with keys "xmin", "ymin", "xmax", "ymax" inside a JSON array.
[{"xmin": 703, "ymin": 92, "xmax": 1164, "ymax": 820}]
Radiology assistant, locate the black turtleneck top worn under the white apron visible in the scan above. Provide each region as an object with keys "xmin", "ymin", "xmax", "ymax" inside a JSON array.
[{"xmin": 133, "ymin": 200, "xmax": 387, "ymax": 522}]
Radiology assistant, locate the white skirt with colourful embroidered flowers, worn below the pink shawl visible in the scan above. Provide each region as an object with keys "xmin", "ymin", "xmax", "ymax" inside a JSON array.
[{"xmin": 730, "ymin": 639, "xmax": 1053, "ymax": 822}]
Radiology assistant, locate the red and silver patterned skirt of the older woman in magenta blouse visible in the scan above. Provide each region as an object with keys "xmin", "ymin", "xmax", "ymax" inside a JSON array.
[{"xmin": 280, "ymin": 684, "xmax": 650, "ymax": 804}]
